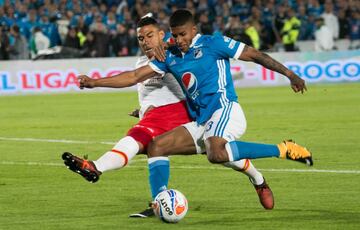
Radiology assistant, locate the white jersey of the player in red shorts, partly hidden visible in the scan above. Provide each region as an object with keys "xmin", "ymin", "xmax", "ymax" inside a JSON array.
[{"xmin": 136, "ymin": 56, "xmax": 185, "ymax": 118}]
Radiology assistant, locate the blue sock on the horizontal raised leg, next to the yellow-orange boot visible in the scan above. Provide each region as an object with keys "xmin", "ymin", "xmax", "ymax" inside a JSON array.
[{"xmin": 226, "ymin": 141, "xmax": 280, "ymax": 161}]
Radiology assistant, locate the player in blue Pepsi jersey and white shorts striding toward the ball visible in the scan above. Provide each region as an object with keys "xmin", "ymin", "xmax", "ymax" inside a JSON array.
[{"xmin": 78, "ymin": 10, "xmax": 313, "ymax": 210}]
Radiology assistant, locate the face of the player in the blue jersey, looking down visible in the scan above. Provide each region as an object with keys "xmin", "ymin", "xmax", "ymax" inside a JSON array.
[{"xmin": 171, "ymin": 22, "xmax": 197, "ymax": 53}]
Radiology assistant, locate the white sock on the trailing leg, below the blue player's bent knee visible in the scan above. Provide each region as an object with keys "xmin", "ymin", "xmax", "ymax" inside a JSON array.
[{"xmin": 223, "ymin": 159, "xmax": 264, "ymax": 185}]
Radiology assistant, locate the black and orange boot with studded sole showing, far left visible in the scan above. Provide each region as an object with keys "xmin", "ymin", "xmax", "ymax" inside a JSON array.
[{"xmin": 62, "ymin": 152, "xmax": 101, "ymax": 183}]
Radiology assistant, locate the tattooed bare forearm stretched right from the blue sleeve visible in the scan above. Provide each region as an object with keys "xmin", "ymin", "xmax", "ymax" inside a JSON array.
[{"xmin": 239, "ymin": 45, "xmax": 306, "ymax": 93}]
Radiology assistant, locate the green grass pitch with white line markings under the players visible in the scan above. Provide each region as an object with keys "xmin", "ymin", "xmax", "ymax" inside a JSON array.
[{"xmin": 0, "ymin": 83, "xmax": 360, "ymax": 230}]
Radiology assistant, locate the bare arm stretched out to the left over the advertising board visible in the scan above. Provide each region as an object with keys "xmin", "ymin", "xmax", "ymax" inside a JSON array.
[{"xmin": 78, "ymin": 65, "xmax": 156, "ymax": 89}]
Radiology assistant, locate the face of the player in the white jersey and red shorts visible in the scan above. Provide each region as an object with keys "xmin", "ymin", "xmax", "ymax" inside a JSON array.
[{"xmin": 137, "ymin": 25, "xmax": 165, "ymax": 58}]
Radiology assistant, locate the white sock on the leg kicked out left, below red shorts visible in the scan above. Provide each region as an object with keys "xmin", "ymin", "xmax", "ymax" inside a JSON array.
[{"xmin": 94, "ymin": 136, "xmax": 139, "ymax": 172}]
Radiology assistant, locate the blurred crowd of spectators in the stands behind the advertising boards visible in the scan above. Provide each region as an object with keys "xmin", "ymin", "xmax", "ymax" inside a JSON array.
[{"xmin": 0, "ymin": 0, "xmax": 360, "ymax": 60}]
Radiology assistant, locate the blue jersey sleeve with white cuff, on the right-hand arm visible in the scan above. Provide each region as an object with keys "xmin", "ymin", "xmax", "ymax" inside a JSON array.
[{"xmin": 211, "ymin": 36, "xmax": 245, "ymax": 59}]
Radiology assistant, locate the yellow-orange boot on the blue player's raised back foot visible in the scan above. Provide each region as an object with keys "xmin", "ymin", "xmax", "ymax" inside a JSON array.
[{"xmin": 278, "ymin": 140, "xmax": 313, "ymax": 166}]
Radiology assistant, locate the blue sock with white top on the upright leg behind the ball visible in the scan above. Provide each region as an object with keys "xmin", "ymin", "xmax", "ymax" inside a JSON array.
[{"xmin": 148, "ymin": 157, "xmax": 170, "ymax": 200}]
